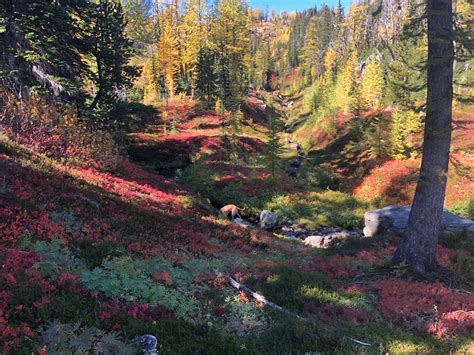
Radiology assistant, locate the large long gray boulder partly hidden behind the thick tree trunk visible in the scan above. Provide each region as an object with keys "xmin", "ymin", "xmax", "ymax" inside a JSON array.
[{"xmin": 364, "ymin": 206, "xmax": 474, "ymax": 240}]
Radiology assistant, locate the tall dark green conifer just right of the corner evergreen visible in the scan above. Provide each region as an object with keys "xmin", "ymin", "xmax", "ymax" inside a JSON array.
[{"xmin": 90, "ymin": 0, "xmax": 137, "ymax": 110}]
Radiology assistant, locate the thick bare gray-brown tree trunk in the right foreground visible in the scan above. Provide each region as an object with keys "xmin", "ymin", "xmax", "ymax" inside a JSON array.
[{"xmin": 394, "ymin": 0, "xmax": 454, "ymax": 273}]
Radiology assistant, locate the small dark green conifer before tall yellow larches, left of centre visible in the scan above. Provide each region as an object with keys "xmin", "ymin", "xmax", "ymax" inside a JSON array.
[{"xmin": 196, "ymin": 47, "xmax": 217, "ymax": 108}]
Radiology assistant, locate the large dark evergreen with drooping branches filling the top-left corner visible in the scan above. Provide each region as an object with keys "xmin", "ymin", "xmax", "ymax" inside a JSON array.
[{"xmin": 0, "ymin": 0, "xmax": 93, "ymax": 104}]
